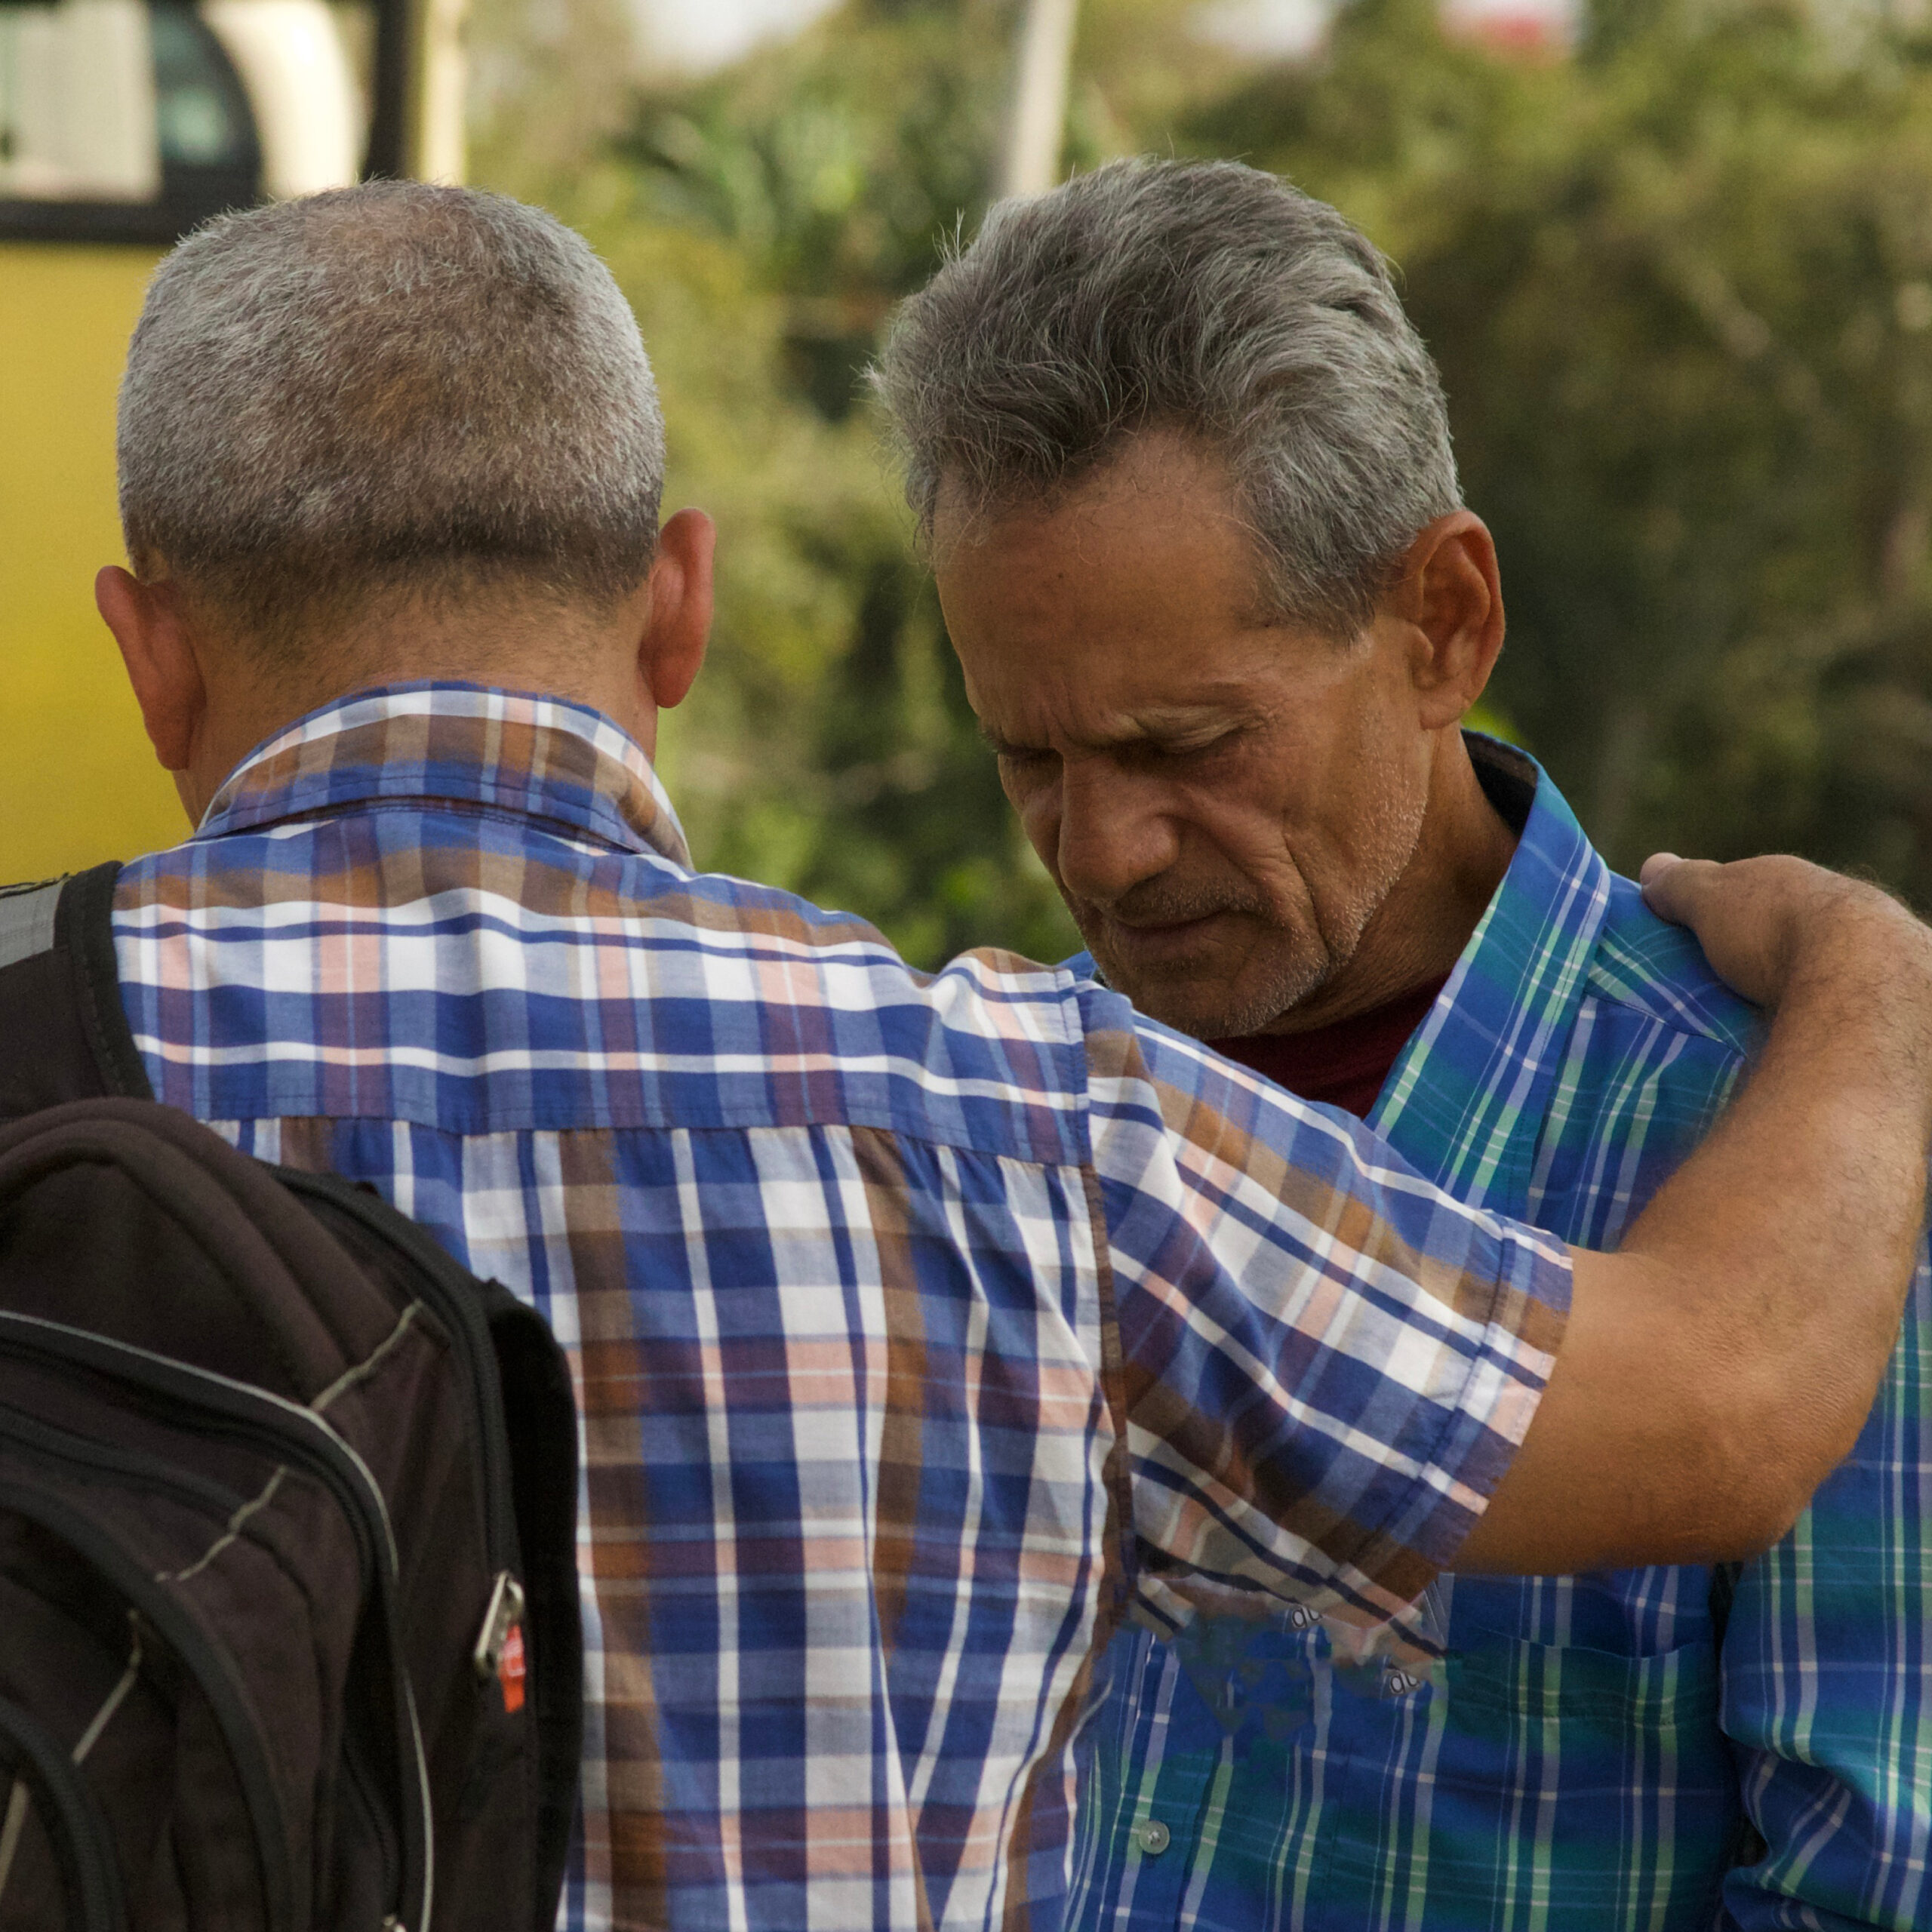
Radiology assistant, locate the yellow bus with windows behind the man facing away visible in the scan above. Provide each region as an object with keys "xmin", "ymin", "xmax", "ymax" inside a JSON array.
[{"xmin": 0, "ymin": 0, "xmax": 462, "ymax": 883}]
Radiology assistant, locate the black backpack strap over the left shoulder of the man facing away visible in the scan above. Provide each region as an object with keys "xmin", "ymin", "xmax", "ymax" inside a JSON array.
[{"xmin": 0, "ymin": 862, "xmax": 155, "ymax": 1121}]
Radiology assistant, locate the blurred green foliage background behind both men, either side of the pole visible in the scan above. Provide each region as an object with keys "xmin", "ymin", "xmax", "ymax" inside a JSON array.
[{"xmin": 477, "ymin": 0, "xmax": 1932, "ymax": 962}]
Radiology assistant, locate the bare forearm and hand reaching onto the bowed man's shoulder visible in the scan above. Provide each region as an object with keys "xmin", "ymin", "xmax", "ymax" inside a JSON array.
[{"xmin": 1457, "ymin": 862, "xmax": 1932, "ymax": 1573}]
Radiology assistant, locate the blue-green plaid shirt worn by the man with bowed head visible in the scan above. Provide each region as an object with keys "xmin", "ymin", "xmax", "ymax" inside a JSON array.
[{"xmin": 1074, "ymin": 740, "xmax": 1932, "ymax": 1932}]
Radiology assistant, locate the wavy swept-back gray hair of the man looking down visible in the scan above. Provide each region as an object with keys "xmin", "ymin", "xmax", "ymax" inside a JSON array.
[{"xmin": 873, "ymin": 160, "xmax": 1460, "ymax": 635}]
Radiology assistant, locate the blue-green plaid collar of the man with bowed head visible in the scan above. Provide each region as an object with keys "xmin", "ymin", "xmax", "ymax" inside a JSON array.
[{"xmin": 1367, "ymin": 734, "xmax": 1611, "ymax": 1214}]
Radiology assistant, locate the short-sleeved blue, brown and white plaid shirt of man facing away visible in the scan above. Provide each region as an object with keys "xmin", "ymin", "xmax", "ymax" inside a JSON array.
[{"xmin": 114, "ymin": 684, "xmax": 1569, "ymax": 1932}]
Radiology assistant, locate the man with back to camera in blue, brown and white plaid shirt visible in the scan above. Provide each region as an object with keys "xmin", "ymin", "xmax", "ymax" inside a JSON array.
[{"xmin": 60, "ymin": 183, "xmax": 1932, "ymax": 1932}]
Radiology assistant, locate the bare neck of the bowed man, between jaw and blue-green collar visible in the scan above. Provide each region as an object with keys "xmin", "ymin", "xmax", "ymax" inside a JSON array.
[{"xmin": 1258, "ymin": 731, "xmax": 1517, "ymax": 1034}]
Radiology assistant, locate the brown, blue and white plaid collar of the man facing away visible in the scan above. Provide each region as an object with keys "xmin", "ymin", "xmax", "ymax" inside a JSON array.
[{"xmin": 195, "ymin": 682, "xmax": 691, "ymax": 867}]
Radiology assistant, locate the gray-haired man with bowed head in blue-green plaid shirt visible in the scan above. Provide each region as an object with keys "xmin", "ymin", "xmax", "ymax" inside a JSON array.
[{"xmin": 881, "ymin": 162, "xmax": 1932, "ymax": 1932}]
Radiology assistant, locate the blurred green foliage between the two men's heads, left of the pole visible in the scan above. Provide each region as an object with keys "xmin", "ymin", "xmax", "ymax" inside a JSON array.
[{"xmin": 461, "ymin": 0, "xmax": 1076, "ymax": 964}]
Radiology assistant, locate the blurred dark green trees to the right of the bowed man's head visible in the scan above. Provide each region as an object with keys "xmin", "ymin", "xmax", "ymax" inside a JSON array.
[{"xmin": 1183, "ymin": 0, "xmax": 1932, "ymax": 903}]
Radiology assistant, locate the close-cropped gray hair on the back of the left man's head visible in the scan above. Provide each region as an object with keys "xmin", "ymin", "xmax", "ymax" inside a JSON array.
[{"xmin": 120, "ymin": 182, "xmax": 665, "ymax": 641}]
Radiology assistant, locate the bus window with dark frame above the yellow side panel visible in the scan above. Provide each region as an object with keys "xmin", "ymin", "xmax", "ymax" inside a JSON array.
[{"xmin": 0, "ymin": 0, "xmax": 380, "ymax": 242}]
